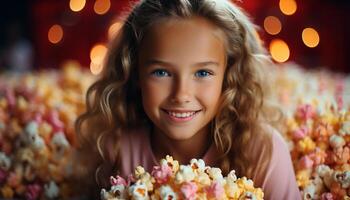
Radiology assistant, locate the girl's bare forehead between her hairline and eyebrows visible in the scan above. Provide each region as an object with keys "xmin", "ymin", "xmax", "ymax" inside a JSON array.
[{"xmin": 140, "ymin": 17, "xmax": 226, "ymax": 65}]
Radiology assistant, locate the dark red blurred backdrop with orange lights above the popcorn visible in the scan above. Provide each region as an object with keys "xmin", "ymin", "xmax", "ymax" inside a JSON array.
[{"xmin": 0, "ymin": 0, "xmax": 350, "ymax": 73}]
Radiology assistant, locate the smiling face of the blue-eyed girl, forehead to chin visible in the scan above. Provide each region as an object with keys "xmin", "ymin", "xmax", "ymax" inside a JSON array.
[{"xmin": 138, "ymin": 17, "xmax": 226, "ymax": 140}]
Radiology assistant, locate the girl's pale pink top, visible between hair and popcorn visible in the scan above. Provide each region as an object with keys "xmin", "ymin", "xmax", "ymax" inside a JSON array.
[{"xmin": 120, "ymin": 129, "xmax": 301, "ymax": 200}]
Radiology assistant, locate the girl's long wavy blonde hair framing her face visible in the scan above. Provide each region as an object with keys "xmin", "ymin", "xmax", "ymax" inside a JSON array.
[{"xmin": 76, "ymin": 0, "xmax": 279, "ymax": 191}]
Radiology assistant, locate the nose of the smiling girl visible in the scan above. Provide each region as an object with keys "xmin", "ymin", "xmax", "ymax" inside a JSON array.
[{"xmin": 170, "ymin": 78, "xmax": 192, "ymax": 104}]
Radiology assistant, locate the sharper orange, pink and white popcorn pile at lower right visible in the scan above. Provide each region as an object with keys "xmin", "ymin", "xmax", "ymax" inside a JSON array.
[{"xmin": 287, "ymin": 104, "xmax": 350, "ymax": 199}]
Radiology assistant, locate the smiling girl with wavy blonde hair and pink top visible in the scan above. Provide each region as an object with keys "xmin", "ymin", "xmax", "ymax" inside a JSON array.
[{"xmin": 76, "ymin": 0, "xmax": 300, "ymax": 199}]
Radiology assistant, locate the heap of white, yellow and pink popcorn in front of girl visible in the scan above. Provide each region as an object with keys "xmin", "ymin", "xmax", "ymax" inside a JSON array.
[{"xmin": 101, "ymin": 156, "xmax": 264, "ymax": 200}]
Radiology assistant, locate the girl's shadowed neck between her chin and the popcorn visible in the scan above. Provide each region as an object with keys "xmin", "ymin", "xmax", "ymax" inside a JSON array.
[{"xmin": 151, "ymin": 126, "xmax": 212, "ymax": 164}]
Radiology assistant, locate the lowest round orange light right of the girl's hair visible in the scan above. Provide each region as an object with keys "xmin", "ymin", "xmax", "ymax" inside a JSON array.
[{"xmin": 270, "ymin": 39, "xmax": 290, "ymax": 62}]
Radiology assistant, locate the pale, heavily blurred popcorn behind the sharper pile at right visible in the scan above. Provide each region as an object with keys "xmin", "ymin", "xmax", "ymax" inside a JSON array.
[{"xmin": 269, "ymin": 63, "xmax": 350, "ymax": 117}]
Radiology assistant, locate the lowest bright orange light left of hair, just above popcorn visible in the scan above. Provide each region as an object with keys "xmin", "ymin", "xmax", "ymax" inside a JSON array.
[{"xmin": 90, "ymin": 44, "xmax": 107, "ymax": 75}]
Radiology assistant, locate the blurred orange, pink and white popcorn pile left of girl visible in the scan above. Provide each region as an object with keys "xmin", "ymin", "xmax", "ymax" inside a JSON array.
[{"xmin": 0, "ymin": 63, "xmax": 93, "ymax": 199}]
